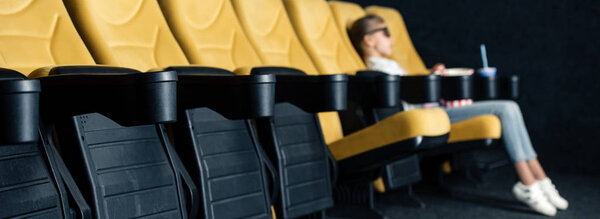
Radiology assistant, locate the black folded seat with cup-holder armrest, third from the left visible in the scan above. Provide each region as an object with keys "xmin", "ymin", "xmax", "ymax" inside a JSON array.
[{"xmin": 170, "ymin": 67, "xmax": 278, "ymax": 218}]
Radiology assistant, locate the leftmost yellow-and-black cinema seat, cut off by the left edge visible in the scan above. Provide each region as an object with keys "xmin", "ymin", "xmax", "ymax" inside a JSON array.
[{"xmin": 0, "ymin": 0, "xmax": 94, "ymax": 218}]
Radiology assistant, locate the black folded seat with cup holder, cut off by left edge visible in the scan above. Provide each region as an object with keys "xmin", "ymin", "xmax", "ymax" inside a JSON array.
[{"xmin": 0, "ymin": 69, "xmax": 66, "ymax": 218}]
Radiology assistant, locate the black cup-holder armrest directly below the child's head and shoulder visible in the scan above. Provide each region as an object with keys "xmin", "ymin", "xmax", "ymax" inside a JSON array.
[{"xmin": 348, "ymin": 71, "xmax": 401, "ymax": 108}]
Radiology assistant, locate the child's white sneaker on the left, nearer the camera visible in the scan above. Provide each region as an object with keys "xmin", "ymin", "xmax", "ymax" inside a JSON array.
[{"xmin": 513, "ymin": 182, "xmax": 556, "ymax": 216}]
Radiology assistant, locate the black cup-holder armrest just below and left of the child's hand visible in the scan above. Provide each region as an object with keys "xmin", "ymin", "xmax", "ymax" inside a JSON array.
[{"xmin": 400, "ymin": 74, "xmax": 441, "ymax": 103}]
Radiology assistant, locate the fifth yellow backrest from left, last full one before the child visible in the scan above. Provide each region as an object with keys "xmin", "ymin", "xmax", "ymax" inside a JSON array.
[{"xmin": 285, "ymin": 0, "xmax": 365, "ymax": 74}]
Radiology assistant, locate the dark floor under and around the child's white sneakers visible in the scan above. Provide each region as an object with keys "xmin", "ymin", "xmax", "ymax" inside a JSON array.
[{"xmin": 377, "ymin": 168, "xmax": 600, "ymax": 219}]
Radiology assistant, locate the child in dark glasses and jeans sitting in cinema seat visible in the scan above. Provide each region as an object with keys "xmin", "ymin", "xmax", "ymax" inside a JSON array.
[{"xmin": 350, "ymin": 15, "xmax": 569, "ymax": 216}]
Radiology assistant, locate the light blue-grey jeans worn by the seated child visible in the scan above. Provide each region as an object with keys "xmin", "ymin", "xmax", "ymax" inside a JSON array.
[{"xmin": 446, "ymin": 100, "xmax": 537, "ymax": 163}]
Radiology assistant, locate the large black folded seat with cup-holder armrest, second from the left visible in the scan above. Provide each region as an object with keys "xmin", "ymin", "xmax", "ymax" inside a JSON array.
[{"xmin": 40, "ymin": 67, "xmax": 197, "ymax": 218}]
